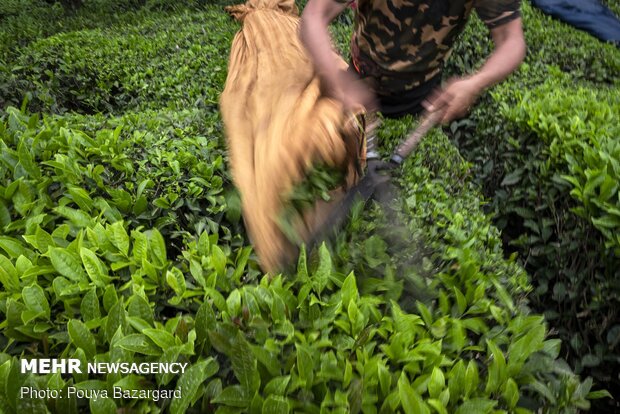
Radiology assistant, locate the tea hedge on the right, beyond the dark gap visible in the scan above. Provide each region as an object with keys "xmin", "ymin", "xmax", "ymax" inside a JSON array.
[{"xmin": 447, "ymin": 4, "xmax": 620, "ymax": 412}]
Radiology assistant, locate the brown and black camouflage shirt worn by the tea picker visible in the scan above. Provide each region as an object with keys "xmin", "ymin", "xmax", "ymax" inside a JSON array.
[{"xmin": 335, "ymin": 0, "xmax": 520, "ymax": 94}]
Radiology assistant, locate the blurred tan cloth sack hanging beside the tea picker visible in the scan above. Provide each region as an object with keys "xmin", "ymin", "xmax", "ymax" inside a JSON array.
[{"xmin": 220, "ymin": 0, "xmax": 365, "ymax": 272}]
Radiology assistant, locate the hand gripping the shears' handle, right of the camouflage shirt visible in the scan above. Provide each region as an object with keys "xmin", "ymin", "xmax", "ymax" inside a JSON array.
[{"xmin": 423, "ymin": 78, "xmax": 482, "ymax": 124}]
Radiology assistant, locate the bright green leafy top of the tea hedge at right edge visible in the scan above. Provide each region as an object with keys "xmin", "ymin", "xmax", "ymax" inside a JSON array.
[{"xmin": 503, "ymin": 75, "xmax": 620, "ymax": 256}]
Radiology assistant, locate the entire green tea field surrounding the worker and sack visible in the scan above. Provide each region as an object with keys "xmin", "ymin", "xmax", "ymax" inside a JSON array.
[{"xmin": 0, "ymin": 0, "xmax": 620, "ymax": 414}]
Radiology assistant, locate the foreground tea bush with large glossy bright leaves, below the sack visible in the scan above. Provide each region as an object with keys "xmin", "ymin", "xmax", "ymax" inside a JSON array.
[{"xmin": 0, "ymin": 105, "xmax": 602, "ymax": 412}]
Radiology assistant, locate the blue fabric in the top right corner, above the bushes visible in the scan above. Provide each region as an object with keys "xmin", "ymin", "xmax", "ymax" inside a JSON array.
[{"xmin": 532, "ymin": 0, "xmax": 620, "ymax": 46}]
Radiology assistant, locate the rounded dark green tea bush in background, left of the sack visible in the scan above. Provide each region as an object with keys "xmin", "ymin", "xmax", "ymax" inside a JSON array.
[{"xmin": 0, "ymin": 11, "xmax": 236, "ymax": 113}]
